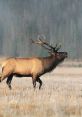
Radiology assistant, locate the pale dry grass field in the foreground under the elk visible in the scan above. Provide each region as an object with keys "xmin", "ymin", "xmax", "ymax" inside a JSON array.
[{"xmin": 0, "ymin": 60, "xmax": 82, "ymax": 117}]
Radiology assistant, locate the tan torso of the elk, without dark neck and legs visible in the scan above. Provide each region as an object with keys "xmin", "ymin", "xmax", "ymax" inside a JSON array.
[{"xmin": 2, "ymin": 58, "xmax": 42, "ymax": 76}]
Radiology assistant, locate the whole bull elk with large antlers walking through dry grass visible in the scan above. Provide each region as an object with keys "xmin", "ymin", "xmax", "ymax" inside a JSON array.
[{"xmin": 0, "ymin": 38, "xmax": 67, "ymax": 89}]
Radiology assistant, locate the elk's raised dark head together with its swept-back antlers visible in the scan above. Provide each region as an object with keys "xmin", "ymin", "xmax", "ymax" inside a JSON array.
[{"xmin": 32, "ymin": 37, "xmax": 68, "ymax": 61}]
